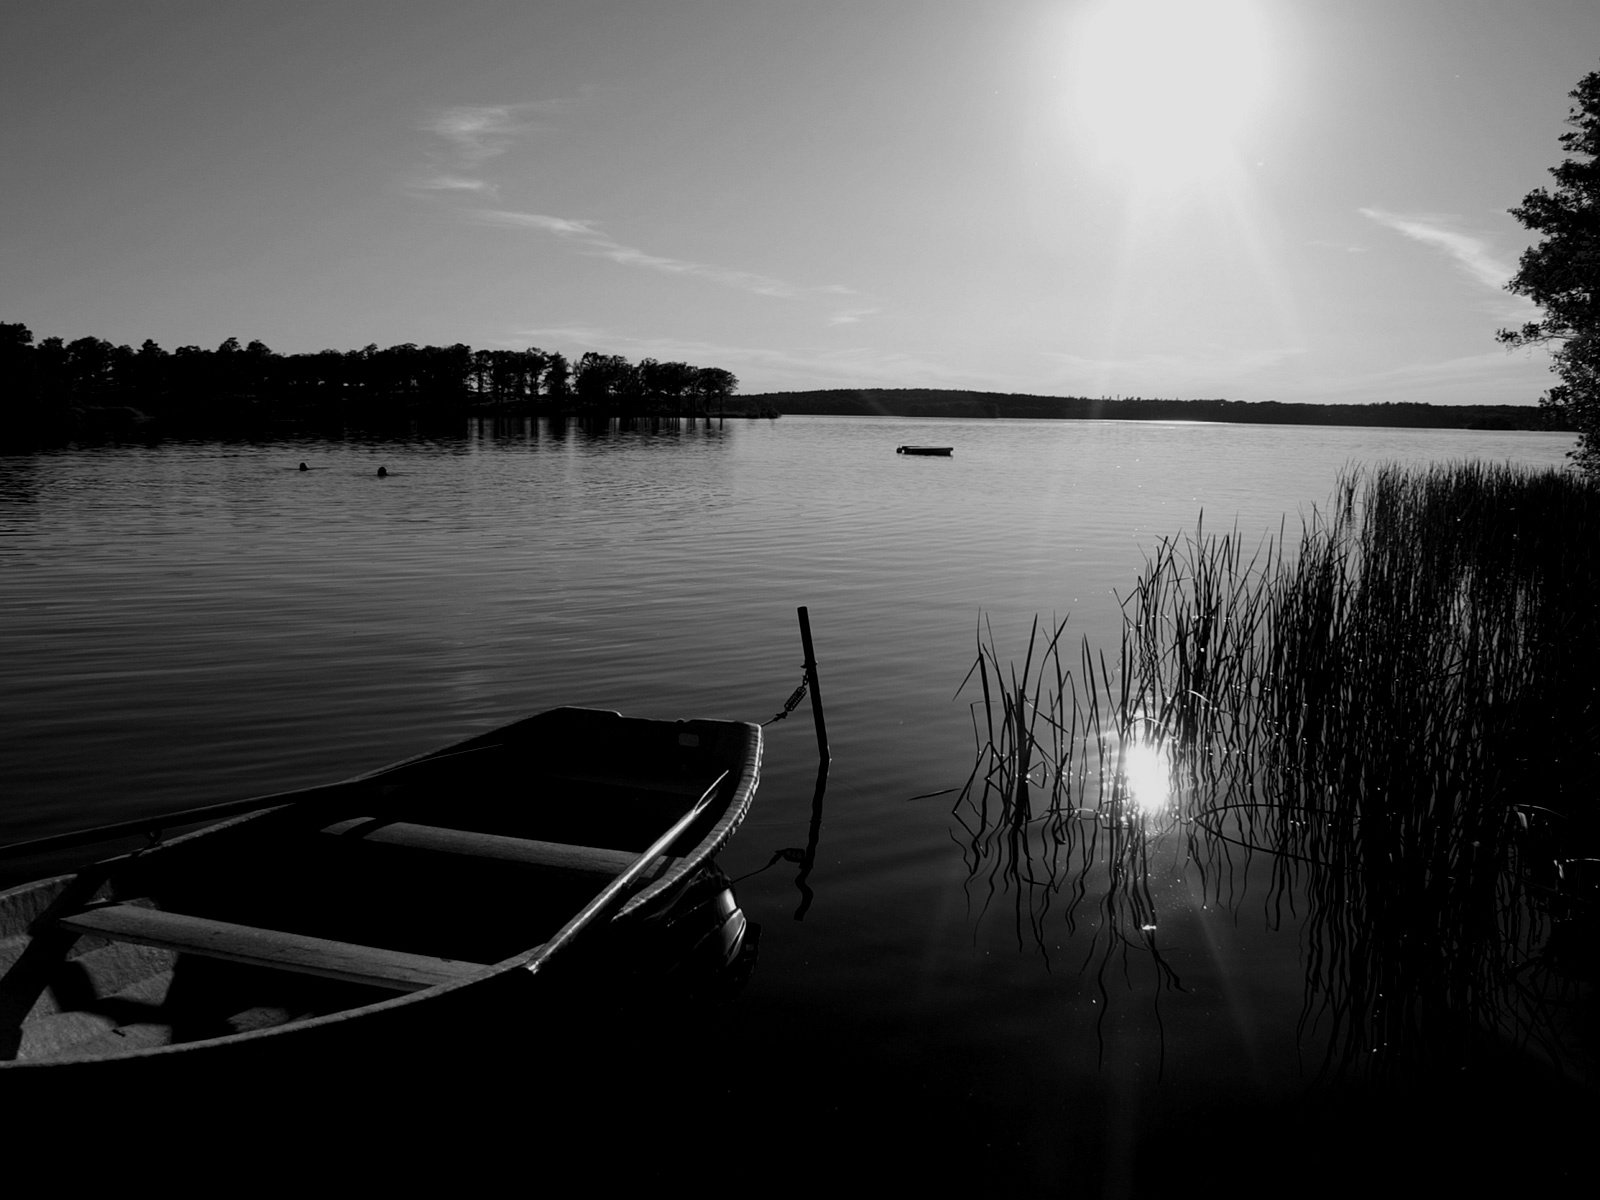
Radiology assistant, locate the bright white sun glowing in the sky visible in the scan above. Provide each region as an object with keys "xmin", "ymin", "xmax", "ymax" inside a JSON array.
[{"xmin": 1072, "ymin": 0, "xmax": 1267, "ymax": 181}]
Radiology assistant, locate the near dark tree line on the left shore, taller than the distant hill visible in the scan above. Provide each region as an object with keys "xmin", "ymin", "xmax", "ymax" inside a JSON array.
[{"xmin": 0, "ymin": 323, "xmax": 741, "ymax": 443}]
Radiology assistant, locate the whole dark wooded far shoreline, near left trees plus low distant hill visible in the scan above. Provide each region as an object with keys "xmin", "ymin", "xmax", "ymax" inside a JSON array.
[{"xmin": 0, "ymin": 323, "xmax": 1566, "ymax": 448}]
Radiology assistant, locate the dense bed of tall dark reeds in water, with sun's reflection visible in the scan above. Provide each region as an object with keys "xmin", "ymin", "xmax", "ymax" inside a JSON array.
[{"xmin": 957, "ymin": 462, "xmax": 1600, "ymax": 1070}]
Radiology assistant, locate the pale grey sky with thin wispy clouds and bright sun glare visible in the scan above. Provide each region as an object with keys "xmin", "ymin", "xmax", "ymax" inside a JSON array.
[{"xmin": 0, "ymin": 0, "xmax": 1600, "ymax": 403}]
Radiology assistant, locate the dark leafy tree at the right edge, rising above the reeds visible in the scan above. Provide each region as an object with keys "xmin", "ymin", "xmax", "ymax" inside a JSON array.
[{"xmin": 1499, "ymin": 70, "xmax": 1600, "ymax": 475}]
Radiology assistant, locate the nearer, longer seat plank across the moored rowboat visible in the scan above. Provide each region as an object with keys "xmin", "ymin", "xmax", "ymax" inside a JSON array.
[{"xmin": 56, "ymin": 904, "xmax": 483, "ymax": 992}]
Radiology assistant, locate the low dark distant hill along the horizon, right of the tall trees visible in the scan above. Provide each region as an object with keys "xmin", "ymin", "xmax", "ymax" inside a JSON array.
[{"xmin": 739, "ymin": 387, "xmax": 1570, "ymax": 429}]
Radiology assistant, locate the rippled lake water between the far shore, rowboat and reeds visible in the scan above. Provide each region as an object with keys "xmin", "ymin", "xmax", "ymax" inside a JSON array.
[{"xmin": 0, "ymin": 418, "xmax": 1571, "ymax": 1194}]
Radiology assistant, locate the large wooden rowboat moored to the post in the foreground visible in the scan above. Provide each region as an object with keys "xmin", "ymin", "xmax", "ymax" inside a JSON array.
[{"xmin": 0, "ymin": 709, "xmax": 762, "ymax": 1082}]
